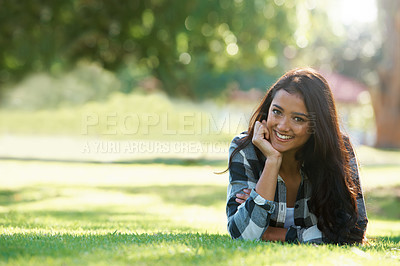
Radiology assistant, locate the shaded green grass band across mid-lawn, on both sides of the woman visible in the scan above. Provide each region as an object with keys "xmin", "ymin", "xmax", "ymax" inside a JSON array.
[{"xmin": 0, "ymin": 185, "xmax": 400, "ymax": 218}]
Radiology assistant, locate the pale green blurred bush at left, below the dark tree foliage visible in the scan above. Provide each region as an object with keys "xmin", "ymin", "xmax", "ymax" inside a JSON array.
[{"xmin": 2, "ymin": 64, "xmax": 121, "ymax": 111}]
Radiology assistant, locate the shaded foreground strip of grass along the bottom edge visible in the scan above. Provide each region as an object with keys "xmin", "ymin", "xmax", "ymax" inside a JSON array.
[{"xmin": 1, "ymin": 232, "xmax": 398, "ymax": 265}]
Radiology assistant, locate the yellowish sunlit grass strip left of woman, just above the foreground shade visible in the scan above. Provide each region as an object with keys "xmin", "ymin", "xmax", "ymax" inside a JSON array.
[{"xmin": 0, "ymin": 210, "xmax": 188, "ymax": 232}]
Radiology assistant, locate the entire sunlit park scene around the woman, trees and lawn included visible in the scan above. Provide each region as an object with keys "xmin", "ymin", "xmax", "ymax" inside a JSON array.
[{"xmin": 0, "ymin": 0, "xmax": 400, "ymax": 265}]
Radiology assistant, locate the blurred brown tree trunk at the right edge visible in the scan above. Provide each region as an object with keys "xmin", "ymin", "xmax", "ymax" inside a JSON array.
[{"xmin": 372, "ymin": 0, "xmax": 400, "ymax": 148}]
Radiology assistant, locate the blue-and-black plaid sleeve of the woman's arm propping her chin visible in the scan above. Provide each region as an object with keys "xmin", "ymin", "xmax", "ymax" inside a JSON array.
[{"xmin": 226, "ymin": 138, "xmax": 275, "ymax": 240}]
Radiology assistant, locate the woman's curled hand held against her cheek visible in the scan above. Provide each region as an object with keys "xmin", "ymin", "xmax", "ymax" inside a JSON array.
[{"xmin": 252, "ymin": 120, "xmax": 282, "ymax": 158}]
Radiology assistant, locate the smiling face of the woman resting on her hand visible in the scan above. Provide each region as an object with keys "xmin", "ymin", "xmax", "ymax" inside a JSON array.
[{"xmin": 267, "ymin": 89, "xmax": 310, "ymax": 156}]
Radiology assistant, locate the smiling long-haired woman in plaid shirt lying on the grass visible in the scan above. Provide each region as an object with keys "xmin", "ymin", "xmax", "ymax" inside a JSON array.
[{"xmin": 226, "ymin": 69, "xmax": 368, "ymax": 244}]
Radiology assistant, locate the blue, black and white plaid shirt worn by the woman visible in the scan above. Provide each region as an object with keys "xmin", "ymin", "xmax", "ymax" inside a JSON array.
[{"xmin": 226, "ymin": 133, "xmax": 368, "ymax": 243}]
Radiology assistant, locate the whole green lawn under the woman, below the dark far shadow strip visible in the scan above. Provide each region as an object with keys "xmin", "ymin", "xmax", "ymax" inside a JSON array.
[{"xmin": 0, "ymin": 161, "xmax": 400, "ymax": 265}]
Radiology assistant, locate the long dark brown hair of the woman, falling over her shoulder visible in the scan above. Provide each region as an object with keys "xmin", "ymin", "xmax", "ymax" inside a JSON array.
[{"xmin": 228, "ymin": 68, "xmax": 363, "ymax": 244}]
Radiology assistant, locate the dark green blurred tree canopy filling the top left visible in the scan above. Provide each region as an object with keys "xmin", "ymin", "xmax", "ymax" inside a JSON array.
[{"xmin": 0, "ymin": 0, "xmax": 324, "ymax": 98}]
